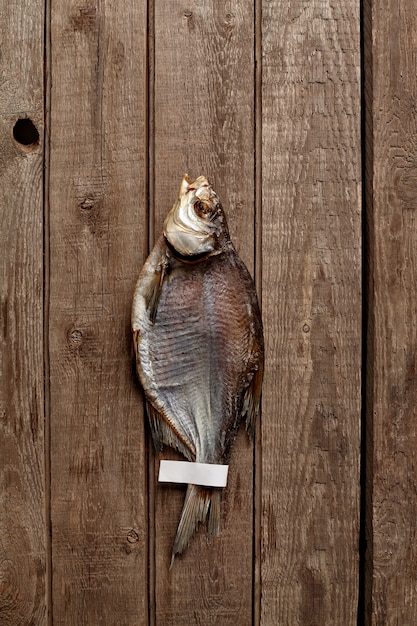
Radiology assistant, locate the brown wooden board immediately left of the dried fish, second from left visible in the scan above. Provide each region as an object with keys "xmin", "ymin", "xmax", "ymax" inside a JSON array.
[{"xmin": 50, "ymin": 0, "xmax": 147, "ymax": 626}]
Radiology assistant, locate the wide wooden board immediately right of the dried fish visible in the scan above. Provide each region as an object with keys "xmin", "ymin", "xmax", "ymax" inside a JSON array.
[{"xmin": 261, "ymin": 0, "xmax": 361, "ymax": 626}]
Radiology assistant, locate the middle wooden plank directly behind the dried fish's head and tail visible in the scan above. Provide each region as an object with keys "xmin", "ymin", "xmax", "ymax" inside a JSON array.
[{"xmin": 151, "ymin": 0, "xmax": 254, "ymax": 626}]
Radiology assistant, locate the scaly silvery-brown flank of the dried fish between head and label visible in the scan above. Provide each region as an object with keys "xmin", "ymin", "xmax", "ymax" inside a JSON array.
[{"xmin": 141, "ymin": 250, "xmax": 253, "ymax": 463}]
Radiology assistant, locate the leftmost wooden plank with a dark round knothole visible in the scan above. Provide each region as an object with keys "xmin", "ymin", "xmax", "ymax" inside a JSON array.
[{"xmin": 0, "ymin": 0, "xmax": 48, "ymax": 626}]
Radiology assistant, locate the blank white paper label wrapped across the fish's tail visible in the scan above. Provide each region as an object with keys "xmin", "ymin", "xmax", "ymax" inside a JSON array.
[{"xmin": 158, "ymin": 461, "xmax": 229, "ymax": 487}]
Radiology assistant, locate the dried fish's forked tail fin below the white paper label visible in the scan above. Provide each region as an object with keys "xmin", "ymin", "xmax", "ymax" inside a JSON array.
[{"xmin": 171, "ymin": 485, "xmax": 221, "ymax": 566}]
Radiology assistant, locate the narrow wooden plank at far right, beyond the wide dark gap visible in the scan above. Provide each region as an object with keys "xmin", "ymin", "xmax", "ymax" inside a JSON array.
[{"xmin": 366, "ymin": 0, "xmax": 417, "ymax": 626}]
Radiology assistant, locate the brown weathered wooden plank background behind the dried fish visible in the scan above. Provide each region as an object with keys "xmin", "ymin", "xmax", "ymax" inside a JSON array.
[{"xmin": 0, "ymin": 0, "xmax": 417, "ymax": 626}]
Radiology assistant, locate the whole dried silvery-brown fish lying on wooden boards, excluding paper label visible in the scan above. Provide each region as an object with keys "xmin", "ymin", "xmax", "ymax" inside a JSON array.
[{"xmin": 132, "ymin": 176, "xmax": 264, "ymax": 558}]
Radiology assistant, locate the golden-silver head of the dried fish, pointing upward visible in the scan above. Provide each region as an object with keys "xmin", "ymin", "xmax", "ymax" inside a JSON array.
[{"xmin": 164, "ymin": 174, "xmax": 231, "ymax": 258}]
